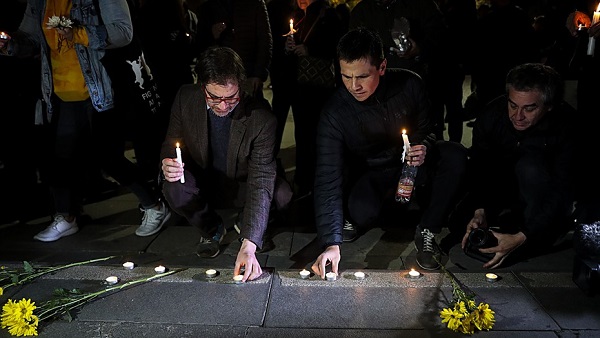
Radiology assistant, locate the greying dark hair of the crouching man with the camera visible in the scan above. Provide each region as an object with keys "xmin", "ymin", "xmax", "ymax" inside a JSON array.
[{"xmin": 506, "ymin": 63, "xmax": 563, "ymax": 105}]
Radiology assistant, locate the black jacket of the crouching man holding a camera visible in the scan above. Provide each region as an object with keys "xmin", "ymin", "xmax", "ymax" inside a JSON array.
[{"xmin": 469, "ymin": 96, "xmax": 576, "ymax": 240}]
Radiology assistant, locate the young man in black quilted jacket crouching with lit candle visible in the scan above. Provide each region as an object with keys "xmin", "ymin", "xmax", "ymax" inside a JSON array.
[{"xmin": 312, "ymin": 28, "xmax": 466, "ymax": 278}]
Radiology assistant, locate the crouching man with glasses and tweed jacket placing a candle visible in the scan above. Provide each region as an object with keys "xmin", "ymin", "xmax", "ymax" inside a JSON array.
[{"xmin": 161, "ymin": 47, "xmax": 292, "ymax": 281}]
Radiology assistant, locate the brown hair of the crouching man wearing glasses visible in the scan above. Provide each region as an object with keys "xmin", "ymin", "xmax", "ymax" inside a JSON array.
[{"xmin": 196, "ymin": 46, "xmax": 246, "ymax": 86}]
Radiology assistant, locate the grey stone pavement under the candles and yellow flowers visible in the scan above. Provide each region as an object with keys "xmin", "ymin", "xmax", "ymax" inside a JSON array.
[{"xmin": 0, "ymin": 184, "xmax": 600, "ymax": 338}]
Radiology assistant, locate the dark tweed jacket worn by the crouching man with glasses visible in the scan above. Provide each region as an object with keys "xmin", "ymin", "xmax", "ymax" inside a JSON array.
[{"xmin": 160, "ymin": 84, "xmax": 276, "ymax": 248}]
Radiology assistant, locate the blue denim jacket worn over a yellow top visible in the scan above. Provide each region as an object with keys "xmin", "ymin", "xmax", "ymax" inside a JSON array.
[{"xmin": 7, "ymin": 0, "xmax": 133, "ymax": 121}]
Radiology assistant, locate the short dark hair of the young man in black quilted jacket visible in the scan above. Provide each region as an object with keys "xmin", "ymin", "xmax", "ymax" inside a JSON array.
[{"xmin": 337, "ymin": 27, "xmax": 385, "ymax": 67}]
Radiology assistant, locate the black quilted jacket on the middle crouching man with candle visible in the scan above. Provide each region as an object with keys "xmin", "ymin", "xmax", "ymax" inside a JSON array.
[{"xmin": 314, "ymin": 70, "xmax": 435, "ymax": 246}]
